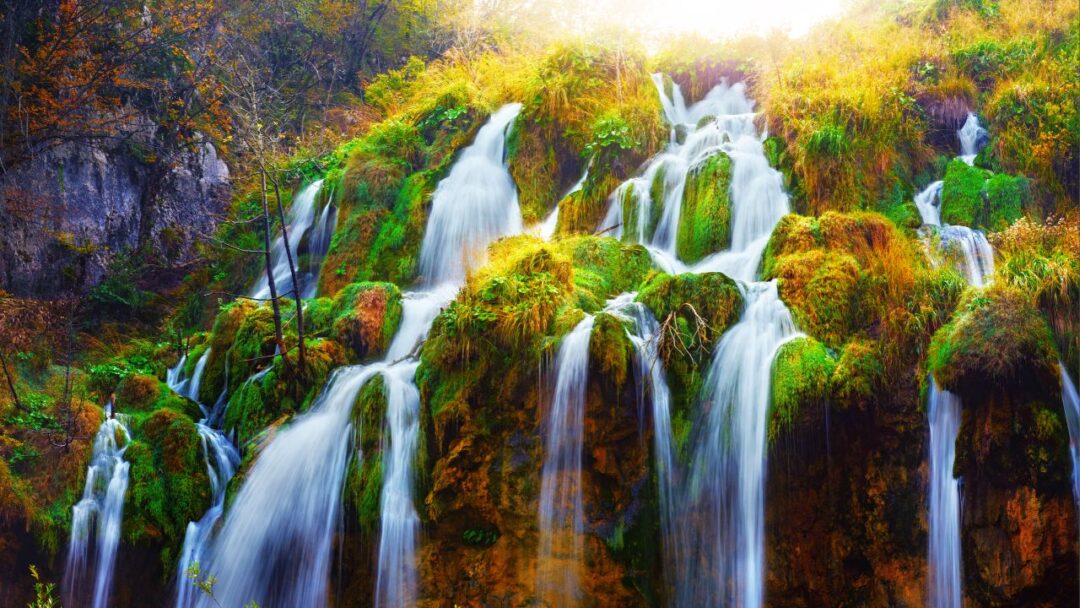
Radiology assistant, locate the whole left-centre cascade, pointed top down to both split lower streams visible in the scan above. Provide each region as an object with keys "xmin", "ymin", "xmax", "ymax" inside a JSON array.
[{"xmin": 198, "ymin": 104, "xmax": 522, "ymax": 608}]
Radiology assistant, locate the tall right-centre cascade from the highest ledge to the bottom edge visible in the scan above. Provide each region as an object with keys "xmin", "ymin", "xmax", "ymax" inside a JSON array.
[{"xmin": 599, "ymin": 76, "xmax": 799, "ymax": 608}]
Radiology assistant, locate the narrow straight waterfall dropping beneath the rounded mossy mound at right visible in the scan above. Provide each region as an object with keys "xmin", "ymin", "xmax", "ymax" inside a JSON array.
[{"xmin": 928, "ymin": 378, "xmax": 962, "ymax": 608}]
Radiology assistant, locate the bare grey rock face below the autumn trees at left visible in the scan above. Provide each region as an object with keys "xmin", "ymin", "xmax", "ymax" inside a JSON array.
[{"xmin": 0, "ymin": 133, "xmax": 231, "ymax": 297}]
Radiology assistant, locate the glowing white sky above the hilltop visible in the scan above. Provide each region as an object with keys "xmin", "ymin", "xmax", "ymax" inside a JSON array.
[{"xmin": 574, "ymin": 0, "xmax": 848, "ymax": 39}]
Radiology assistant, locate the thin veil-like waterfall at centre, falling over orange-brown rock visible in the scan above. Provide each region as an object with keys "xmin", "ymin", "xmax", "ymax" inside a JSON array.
[{"xmin": 537, "ymin": 315, "xmax": 595, "ymax": 606}]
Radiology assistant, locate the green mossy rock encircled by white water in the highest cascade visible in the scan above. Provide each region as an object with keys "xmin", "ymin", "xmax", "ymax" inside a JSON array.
[{"xmin": 676, "ymin": 152, "xmax": 731, "ymax": 262}]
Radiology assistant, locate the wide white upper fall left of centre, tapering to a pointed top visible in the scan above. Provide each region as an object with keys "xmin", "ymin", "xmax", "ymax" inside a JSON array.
[{"xmin": 420, "ymin": 104, "xmax": 522, "ymax": 285}]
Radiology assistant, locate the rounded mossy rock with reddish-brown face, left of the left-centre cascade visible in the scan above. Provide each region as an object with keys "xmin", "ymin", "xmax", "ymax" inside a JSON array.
[{"xmin": 330, "ymin": 283, "xmax": 402, "ymax": 360}]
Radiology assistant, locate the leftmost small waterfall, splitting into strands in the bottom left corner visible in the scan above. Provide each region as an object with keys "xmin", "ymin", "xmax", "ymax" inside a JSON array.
[{"xmin": 64, "ymin": 401, "xmax": 131, "ymax": 608}]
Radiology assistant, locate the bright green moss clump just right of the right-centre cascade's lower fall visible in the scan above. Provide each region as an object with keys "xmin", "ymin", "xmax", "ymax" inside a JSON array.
[{"xmin": 769, "ymin": 338, "xmax": 837, "ymax": 442}]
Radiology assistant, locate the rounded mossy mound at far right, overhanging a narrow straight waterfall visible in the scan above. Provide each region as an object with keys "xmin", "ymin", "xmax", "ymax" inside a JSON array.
[{"xmin": 928, "ymin": 285, "xmax": 1057, "ymax": 395}]
